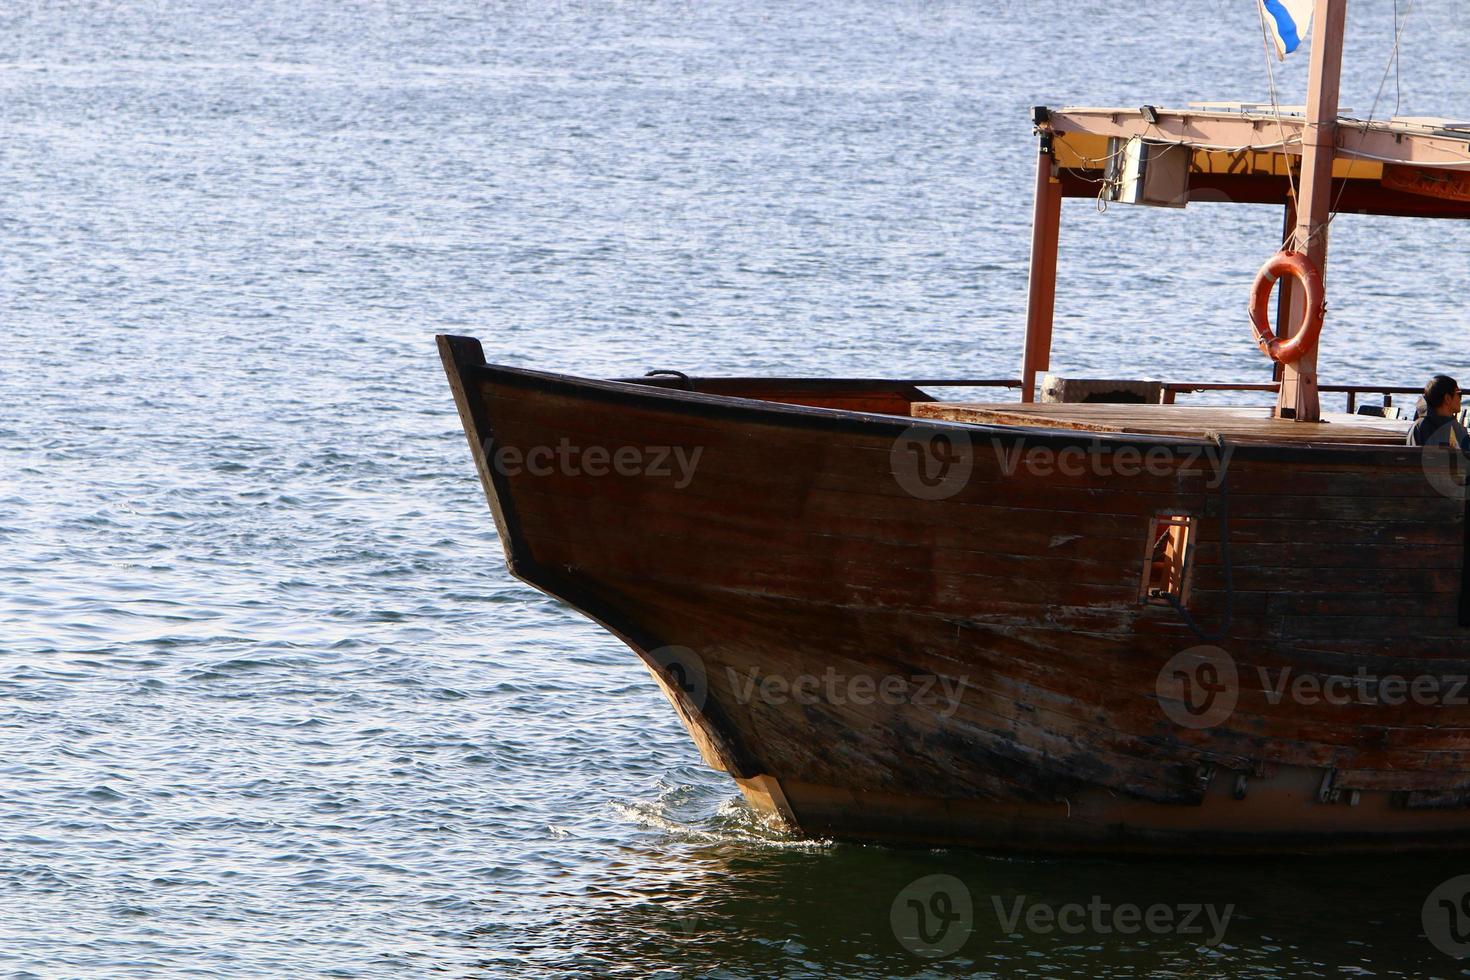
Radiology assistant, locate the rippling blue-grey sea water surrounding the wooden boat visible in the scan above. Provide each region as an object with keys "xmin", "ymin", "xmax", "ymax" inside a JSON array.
[{"xmin": 0, "ymin": 0, "xmax": 1470, "ymax": 977}]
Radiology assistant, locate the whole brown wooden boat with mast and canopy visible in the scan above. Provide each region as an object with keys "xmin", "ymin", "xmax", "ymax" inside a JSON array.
[{"xmin": 440, "ymin": 0, "xmax": 1470, "ymax": 852}]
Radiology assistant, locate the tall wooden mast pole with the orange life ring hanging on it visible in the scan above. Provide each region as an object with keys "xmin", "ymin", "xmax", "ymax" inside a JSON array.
[{"xmin": 1276, "ymin": 0, "xmax": 1348, "ymax": 422}]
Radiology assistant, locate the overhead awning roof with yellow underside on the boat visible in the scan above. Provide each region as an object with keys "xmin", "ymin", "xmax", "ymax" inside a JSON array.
[{"xmin": 1036, "ymin": 103, "xmax": 1470, "ymax": 217}]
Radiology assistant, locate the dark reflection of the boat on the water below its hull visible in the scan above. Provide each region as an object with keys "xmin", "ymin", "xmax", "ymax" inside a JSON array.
[{"xmin": 476, "ymin": 811, "xmax": 1461, "ymax": 977}]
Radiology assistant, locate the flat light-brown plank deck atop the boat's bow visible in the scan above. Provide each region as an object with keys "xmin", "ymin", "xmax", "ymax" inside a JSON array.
[{"xmin": 911, "ymin": 401, "xmax": 1413, "ymax": 445}]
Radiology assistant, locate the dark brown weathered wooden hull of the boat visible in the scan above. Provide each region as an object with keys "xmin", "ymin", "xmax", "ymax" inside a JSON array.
[{"xmin": 441, "ymin": 338, "xmax": 1470, "ymax": 852}]
